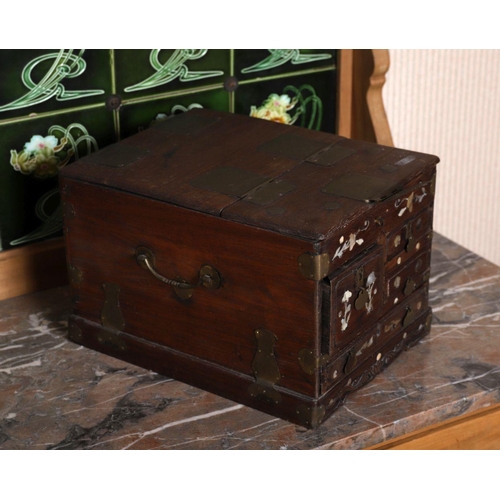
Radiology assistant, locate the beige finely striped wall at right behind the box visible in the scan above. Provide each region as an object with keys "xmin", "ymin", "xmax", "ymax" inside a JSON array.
[{"xmin": 383, "ymin": 49, "xmax": 500, "ymax": 265}]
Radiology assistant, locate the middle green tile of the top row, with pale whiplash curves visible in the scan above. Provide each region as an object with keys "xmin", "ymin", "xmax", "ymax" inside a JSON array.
[{"xmin": 115, "ymin": 49, "xmax": 229, "ymax": 100}]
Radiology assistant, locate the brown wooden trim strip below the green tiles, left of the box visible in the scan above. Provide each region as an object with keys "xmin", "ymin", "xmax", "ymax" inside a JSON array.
[{"xmin": 0, "ymin": 238, "xmax": 68, "ymax": 300}]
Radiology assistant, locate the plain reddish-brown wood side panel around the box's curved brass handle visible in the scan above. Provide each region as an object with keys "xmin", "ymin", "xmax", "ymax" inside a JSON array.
[{"xmin": 63, "ymin": 180, "xmax": 319, "ymax": 396}]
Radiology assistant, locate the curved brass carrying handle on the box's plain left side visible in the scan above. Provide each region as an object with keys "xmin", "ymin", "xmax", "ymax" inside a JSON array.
[{"xmin": 135, "ymin": 247, "xmax": 221, "ymax": 300}]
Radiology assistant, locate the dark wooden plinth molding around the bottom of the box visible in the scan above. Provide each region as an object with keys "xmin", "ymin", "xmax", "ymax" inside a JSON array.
[{"xmin": 69, "ymin": 310, "xmax": 430, "ymax": 429}]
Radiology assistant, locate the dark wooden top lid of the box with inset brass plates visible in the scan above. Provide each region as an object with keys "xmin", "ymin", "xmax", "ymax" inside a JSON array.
[{"xmin": 61, "ymin": 109, "xmax": 439, "ymax": 241}]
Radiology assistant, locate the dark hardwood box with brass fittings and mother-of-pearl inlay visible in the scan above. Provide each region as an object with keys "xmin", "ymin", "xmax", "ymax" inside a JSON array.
[{"xmin": 61, "ymin": 110, "xmax": 439, "ymax": 427}]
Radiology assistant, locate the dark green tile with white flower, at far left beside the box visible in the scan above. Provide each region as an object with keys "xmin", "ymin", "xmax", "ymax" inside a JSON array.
[{"xmin": 0, "ymin": 108, "xmax": 115, "ymax": 250}]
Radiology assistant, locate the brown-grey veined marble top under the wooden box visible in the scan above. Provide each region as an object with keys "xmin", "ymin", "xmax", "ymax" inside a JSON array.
[{"xmin": 0, "ymin": 235, "xmax": 500, "ymax": 449}]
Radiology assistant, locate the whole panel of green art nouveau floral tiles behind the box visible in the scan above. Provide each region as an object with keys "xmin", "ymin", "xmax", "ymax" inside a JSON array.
[{"xmin": 0, "ymin": 49, "xmax": 336, "ymax": 251}]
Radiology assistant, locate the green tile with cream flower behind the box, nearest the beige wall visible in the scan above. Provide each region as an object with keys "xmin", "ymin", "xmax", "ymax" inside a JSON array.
[{"xmin": 235, "ymin": 70, "xmax": 336, "ymax": 133}]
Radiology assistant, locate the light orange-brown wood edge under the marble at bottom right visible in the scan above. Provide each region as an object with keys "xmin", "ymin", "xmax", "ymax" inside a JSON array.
[{"xmin": 369, "ymin": 404, "xmax": 500, "ymax": 450}]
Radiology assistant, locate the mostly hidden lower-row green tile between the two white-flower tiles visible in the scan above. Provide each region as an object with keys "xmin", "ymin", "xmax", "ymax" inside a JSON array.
[{"xmin": 120, "ymin": 90, "xmax": 229, "ymax": 139}]
